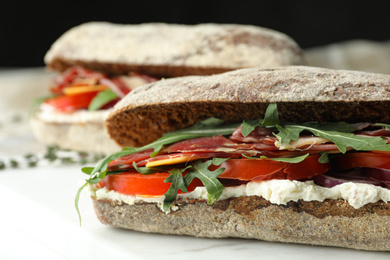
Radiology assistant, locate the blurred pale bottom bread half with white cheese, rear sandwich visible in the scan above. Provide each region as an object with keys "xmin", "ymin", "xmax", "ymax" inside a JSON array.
[{"xmin": 30, "ymin": 111, "xmax": 121, "ymax": 154}]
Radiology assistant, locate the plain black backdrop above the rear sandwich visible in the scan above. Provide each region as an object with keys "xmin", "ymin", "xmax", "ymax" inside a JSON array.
[{"xmin": 0, "ymin": 0, "xmax": 390, "ymax": 67}]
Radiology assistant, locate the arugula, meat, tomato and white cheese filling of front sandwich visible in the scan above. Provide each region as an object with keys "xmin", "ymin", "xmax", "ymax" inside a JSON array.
[{"xmin": 80, "ymin": 104, "xmax": 390, "ymax": 215}]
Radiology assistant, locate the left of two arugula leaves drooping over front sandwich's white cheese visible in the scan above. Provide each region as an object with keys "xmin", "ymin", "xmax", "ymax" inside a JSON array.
[{"xmin": 163, "ymin": 166, "xmax": 191, "ymax": 212}]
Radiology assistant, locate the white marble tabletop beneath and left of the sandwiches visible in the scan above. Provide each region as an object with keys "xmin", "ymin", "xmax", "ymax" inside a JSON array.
[{"xmin": 0, "ymin": 68, "xmax": 390, "ymax": 260}]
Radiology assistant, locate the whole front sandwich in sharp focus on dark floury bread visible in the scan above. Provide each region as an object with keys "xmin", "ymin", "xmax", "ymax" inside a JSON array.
[{"xmin": 76, "ymin": 66, "xmax": 390, "ymax": 251}]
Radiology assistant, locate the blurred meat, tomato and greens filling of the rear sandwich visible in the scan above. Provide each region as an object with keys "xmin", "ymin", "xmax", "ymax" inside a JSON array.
[{"xmin": 41, "ymin": 66, "xmax": 158, "ymax": 115}]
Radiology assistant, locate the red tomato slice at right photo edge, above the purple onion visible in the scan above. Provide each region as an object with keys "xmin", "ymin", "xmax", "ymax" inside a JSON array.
[{"xmin": 332, "ymin": 152, "xmax": 390, "ymax": 170}]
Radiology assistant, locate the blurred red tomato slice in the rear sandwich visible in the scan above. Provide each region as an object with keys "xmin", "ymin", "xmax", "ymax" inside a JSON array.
[{"xmin": 45, "ymin": 91, "xmax": 99, "ymax": 112}]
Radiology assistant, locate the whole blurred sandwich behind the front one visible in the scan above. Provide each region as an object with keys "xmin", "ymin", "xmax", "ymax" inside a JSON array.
[{"xmin": 31, "ymin": 22, "xmax": 305, "ymax": 153}]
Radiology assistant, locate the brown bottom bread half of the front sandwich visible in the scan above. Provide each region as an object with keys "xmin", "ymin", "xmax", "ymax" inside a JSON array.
[{"xmin": 92, "ymin": 196, "xmax": 390, "ymax": 251}]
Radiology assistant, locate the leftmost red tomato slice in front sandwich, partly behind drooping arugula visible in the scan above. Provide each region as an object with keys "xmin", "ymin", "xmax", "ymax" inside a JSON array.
[{"xmin": 99, "ymin": 171, "xmax": 203, "ymax": 196}]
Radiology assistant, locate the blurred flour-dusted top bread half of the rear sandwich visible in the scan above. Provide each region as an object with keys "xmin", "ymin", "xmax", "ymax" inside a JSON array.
[{"xmin": 45, "ymin": 22, "xmax": 305, "ymax": 77}]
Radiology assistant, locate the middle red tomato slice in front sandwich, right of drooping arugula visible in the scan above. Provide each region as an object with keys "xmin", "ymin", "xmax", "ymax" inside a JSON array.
[{"xmin": 210, "ymin": 155, "xmax": 331, "ymax": 181}]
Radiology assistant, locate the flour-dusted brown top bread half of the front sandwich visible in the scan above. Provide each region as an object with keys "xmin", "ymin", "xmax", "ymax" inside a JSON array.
[{"xmin": 106, "ymin": 66, "xmax": 390, "ymax": 147}]
